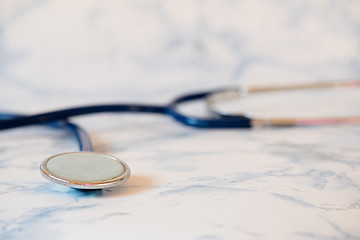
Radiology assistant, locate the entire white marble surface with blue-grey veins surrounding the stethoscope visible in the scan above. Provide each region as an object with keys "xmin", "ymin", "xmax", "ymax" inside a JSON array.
[{"xmin": 0, "ymin": 0, "xmax": 360, "ymax": 240}]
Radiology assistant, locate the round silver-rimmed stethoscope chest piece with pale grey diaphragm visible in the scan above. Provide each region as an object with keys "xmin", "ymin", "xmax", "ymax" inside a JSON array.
[{"xmin": 40, "ymin": 152, "xmax": 130, "ymax": 189}]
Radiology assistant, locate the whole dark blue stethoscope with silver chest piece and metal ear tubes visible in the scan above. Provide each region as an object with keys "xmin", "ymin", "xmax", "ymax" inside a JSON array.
[{"xmin": 0, "ymin": 81, "xmax": 360, "ymax": 189}]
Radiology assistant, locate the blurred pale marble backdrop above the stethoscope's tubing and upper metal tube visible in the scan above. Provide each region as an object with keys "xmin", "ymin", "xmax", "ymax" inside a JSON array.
[{"xmin": 0, "ymin": 0, "xmax": 360, "ymax": 112}]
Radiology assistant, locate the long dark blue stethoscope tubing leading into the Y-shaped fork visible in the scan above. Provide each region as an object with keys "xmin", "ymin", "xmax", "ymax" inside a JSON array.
[{"xmin": 0, "ymin": 92, "xmax": 251, "ymax": 130}]
